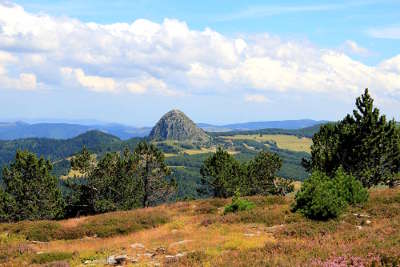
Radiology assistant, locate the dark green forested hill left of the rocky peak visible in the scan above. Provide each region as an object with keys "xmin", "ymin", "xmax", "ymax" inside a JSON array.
[{"xmin": 0, "ymin": 131, "xmax": 141, "ymax": 169}]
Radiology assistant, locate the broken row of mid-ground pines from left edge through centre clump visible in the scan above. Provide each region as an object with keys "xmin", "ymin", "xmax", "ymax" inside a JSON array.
[{"xmin": 0, "ymin": 142, "xmax": 292, "ymax": 221}]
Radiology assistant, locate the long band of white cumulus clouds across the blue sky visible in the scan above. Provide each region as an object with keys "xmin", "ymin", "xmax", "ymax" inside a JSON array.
[{"xmin": 0, "ymin": 3, "xmax": 400, "ymax": 102}]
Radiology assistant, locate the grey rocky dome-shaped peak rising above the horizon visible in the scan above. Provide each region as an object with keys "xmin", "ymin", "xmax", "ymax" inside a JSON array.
[{"xmin": 149, "ymin": 109, "xmax": 210, "ymax": 143}]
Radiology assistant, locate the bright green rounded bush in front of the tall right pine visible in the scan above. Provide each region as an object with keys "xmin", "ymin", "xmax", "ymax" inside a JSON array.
[{"xmin": 292, "ymin": 168, "xmax": 368, "ymax": 220}]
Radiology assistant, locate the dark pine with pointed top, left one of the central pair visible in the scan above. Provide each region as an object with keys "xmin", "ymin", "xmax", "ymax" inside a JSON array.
[{"xmin": 200, "ymin": 147, "xmax": 243, "ymax": 198}]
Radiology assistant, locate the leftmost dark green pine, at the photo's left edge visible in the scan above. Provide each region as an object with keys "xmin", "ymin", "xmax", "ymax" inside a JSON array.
[{"xmin": 1, "ymin": 151, "xmax": 64, "ymax": 221}]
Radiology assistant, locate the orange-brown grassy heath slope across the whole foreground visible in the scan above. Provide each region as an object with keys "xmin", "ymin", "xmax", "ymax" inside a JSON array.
[{"xmin": 0, "ymin": 189, "xmax": 400, "ymax": 266}]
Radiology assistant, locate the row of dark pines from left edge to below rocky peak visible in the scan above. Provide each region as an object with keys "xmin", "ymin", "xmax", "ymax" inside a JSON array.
[{"xmin": 0, "ymin": 142, "xmax": 176, "ymax": 221}]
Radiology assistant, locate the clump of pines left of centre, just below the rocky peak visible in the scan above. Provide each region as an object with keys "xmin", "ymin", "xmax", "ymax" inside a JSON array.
[{"xmin": 65, "ymin": 142, "xmax": 175, "ymax": 216}]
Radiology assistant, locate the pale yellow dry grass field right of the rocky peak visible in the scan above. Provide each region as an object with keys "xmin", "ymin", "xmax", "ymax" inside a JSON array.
[{"xmin": 224, "ymin": 134, "xmax": 312, "ymax": 153}]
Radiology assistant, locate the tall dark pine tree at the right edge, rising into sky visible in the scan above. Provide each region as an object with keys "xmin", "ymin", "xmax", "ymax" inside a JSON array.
[{"xmin": 303, "ymin": 89, "xmax": 400, "ymax": 187}]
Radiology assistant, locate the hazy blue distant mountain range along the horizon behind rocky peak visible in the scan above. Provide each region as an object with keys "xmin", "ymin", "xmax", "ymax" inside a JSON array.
[{"xmin": 0, "ymin": 119, "xmax": 326, "ymax": 140}]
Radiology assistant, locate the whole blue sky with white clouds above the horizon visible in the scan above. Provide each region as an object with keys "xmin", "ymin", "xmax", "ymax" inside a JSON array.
[{"xmin": 0, "ymin": 0, "xmax": 400, "ymax": 126}]
